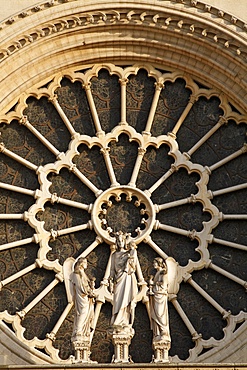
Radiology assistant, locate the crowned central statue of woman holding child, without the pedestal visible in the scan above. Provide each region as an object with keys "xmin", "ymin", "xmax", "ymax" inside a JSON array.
[{"xmin": 110, "ymin": 231, "xmax": 138, "ymax": 328}]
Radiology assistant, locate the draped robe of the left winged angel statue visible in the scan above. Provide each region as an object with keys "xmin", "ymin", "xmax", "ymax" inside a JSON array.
[{"xmin": 72, "ymin": 270, "xmax": 94, "ymax": 340}]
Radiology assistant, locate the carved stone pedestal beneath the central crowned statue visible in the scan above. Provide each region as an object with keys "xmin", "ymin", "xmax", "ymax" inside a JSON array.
[{"xmin": 108, "ymin": 325, "xmax": 135, "ymax": 363}]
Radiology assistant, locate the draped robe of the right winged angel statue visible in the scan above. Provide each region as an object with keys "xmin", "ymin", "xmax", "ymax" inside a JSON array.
[{"xmin": 150, "ymin": 270, "xmax": 171, "ymax": 341}]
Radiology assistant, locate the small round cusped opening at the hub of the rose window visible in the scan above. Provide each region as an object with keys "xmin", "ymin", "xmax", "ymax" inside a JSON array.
[{"xmin": 92, "ymin": 186, "xmax": 155, "ymax": 244}]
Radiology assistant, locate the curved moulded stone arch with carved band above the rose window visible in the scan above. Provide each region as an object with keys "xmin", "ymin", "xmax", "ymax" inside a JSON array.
[{"xmin": 0, "ymin": 1, "xmax": 246, "ymax": 112}]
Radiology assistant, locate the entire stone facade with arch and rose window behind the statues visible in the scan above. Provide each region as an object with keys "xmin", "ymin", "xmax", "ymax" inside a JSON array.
[{"xmin": 0, "ymin": 0, "xmax": 247, "ymax": 369}]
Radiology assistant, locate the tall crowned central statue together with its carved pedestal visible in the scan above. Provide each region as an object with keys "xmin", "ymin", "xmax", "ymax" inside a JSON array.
[{"xmin": 108, "ymin": 231, "xmax": 138, "ymax": 363}]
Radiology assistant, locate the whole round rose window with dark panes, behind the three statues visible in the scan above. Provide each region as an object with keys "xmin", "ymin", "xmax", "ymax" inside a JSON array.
[{"xmin": 0, "ymin": 64, "xmax": 247, "ymax": 362}]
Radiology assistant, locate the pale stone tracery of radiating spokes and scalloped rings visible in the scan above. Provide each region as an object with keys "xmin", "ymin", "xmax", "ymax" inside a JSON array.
[{"xmin": 0, "ymin": 64, "xmax": 246, "ymax": 362}]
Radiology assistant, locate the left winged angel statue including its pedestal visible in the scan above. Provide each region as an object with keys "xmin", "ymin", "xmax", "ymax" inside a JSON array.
[{"xmin": 63, "ymin": 257, "xmax": 94, "ymax": 363}]
